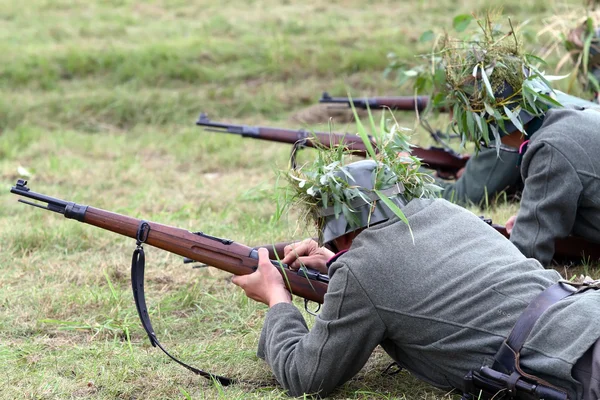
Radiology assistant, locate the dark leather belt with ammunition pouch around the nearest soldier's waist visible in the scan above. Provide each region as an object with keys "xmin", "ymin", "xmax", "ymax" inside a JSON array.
[{"xmin": 463, "ymin": 281, "xmax": 600, "ymax": 400}]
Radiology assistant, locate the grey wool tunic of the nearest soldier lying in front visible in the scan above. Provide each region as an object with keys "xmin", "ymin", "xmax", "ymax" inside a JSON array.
[{"xmin": 258, "ymin": 199, "xmax": 600, "ymax": 399}]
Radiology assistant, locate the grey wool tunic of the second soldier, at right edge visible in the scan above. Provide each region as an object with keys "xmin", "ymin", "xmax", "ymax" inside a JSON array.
[{"xmin": 510, "ymin": 107, "xmax": 600, "ymax": 265}]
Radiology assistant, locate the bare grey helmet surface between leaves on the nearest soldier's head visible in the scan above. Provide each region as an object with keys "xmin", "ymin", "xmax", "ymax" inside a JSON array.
[{"xmin": 319, "ymin": 160, "xmax": 407, "ymax": 243}]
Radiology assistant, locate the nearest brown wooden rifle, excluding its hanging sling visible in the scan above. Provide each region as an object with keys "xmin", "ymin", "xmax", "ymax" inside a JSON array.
[{"xmin": 11, "ymin": 181, "xmax": 329, "ymax": 303}]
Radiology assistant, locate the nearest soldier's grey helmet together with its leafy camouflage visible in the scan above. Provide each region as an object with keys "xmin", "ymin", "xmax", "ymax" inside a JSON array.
[{"xmin": 280, "ymin": 114, "xmax": 441, "ymax": 244}]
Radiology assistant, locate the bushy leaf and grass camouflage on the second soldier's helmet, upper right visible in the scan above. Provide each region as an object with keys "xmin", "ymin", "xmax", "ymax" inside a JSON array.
[{"xmin": 434, "ymin": 14, "xmax": 560, "ymax": 150}]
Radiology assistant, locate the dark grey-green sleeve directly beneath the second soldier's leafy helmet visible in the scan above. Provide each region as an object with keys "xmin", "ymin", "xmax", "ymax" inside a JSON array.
[{"xmin": 438, "ymin": 149, "xmax": 520, "ymax": 205}]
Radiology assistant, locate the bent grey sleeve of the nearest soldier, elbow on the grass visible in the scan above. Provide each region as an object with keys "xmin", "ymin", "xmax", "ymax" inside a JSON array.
[{"xmin": 258, "ymin": 266, "xmax": 385, "ymax": 396}]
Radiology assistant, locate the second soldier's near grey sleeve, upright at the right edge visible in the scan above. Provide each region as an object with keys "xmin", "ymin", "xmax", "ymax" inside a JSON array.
[{"xmin": 510, "ymin": 143, "xmax": 583, "ymax": 266}]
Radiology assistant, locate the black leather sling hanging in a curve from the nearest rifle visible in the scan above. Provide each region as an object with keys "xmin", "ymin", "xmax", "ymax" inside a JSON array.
[{"xmin": 131, "ymin": 221, "xmax": 234, "ymax": 386}]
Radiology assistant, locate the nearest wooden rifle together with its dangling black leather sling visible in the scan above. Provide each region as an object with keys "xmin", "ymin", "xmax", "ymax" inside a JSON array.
[{"xmin": 10, "ymin": 179, "xmax": 329, "ymax": 385}]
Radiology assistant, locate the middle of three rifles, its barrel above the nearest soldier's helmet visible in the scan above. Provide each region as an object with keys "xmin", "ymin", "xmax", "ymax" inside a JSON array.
[{"xmin": 196, "ymin": 113, "xmax": 469, "ymax": 179}]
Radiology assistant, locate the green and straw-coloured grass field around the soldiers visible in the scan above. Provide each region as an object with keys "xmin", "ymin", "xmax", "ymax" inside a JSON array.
[{"xmin": 0, "ymin": 0, "xmax": 597, "ymax": 399}]
